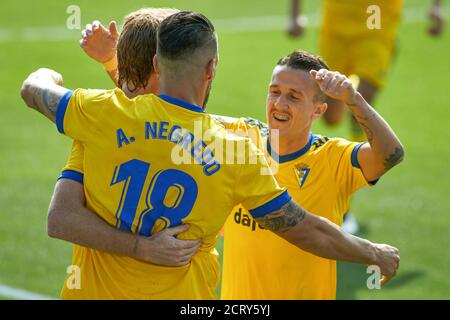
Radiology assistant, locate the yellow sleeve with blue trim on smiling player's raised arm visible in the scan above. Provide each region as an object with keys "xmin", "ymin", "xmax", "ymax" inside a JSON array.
[{"xmin": 327, "ymin": 139, "xmax": 373, "ymax": 198}]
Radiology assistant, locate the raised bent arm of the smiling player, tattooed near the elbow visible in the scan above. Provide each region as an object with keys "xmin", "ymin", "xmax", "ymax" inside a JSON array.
[{"xmin": 311, "ymin": 69, "xmax": 404, "ymax": 181}]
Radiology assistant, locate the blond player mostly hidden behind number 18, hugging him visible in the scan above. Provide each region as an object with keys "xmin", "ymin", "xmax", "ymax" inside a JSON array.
[{"xmin": 48, "ymin": 8, "xmax": 206, "ymax": 267}]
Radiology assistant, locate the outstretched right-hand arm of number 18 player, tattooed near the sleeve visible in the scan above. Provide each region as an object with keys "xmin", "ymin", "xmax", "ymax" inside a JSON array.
[{"xmin": 256, "ymin": 200, "xmax": 400, "ymax": 281}]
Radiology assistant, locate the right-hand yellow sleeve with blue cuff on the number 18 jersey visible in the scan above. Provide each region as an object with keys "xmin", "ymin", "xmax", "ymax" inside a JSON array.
[{"xmin": 234, "ymin": 139, "xmax": 291, "ymax": 218}]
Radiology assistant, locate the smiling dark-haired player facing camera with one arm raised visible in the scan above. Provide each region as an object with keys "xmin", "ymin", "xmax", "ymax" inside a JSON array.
[{"xmin": 221, "ymin": 51, "xmax": 403, "ymax": 299}]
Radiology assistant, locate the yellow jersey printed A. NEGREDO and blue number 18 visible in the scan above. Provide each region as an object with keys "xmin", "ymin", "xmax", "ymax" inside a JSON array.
[{"xmin": 56, "ymin": 89, "xmax": 290, "ymax": 299}]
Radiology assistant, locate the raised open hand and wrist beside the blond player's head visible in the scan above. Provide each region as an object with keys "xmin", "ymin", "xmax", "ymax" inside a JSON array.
[{"xmin": 80, "ymin": 20, "xmax": 119, "ymax": 85}]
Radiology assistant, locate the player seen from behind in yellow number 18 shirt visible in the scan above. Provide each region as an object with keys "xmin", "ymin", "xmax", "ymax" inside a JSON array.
[{"xmin": 21, "ymin": 12, "xmax": 399, "ymax": 299}]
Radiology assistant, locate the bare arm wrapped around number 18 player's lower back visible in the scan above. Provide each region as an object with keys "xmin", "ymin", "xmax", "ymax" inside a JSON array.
[{"xmin": 48, "ymin": 179, "xmax": 201, "ymax": 267}]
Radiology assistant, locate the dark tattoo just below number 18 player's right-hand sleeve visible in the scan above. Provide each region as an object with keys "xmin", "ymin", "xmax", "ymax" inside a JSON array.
[{"xmin": 255, "ymin": 201, "xmax": 306, "ymax": 233}]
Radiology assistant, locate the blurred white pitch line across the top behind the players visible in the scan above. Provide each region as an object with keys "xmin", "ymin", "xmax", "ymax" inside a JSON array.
[{"xmin": 0, "ymin": 6, "xmax": 450, "ymax": 43}]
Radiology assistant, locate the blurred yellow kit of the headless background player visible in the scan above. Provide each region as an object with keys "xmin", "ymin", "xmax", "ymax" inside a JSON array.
[{"xmin": 319, "ymin": 0, "xmax": 404, "ymax": 87}]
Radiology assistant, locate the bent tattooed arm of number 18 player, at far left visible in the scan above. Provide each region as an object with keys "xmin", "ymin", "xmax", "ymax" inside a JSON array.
[{"xmin": 20, "ymin": 68, "xmax": 69, "ymax": 122}]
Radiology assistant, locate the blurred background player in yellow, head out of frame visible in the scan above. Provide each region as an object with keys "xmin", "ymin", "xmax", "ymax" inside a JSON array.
[{"xmin": 288, "ymin": 0, "xmax": 443, "ymax": 233}]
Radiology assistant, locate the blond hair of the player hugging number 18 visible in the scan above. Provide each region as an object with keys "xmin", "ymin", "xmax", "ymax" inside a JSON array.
[{"xmin": 117, "ymin": 8, "xmax": 178, "ymax": 91}]
